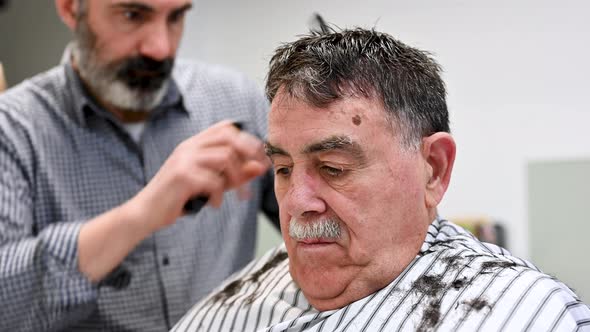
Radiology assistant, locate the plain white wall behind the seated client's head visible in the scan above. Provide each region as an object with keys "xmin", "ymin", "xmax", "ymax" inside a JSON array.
[{"xmin": 180, "ymin": 0, "xmax": 590, "ymax": 257}]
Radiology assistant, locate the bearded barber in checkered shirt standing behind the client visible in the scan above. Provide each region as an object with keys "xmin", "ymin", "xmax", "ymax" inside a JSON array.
[{"xmin": 0, "ymin": 0, "xmax": 278, "ymax": 331}]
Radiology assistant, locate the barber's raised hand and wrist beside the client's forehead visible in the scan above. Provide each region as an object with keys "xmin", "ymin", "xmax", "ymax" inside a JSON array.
[{"xmin": 129, "ymin": 121, "xmax": 270, "ymax": 231}]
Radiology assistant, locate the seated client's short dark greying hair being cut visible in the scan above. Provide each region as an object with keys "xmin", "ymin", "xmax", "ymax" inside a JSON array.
[{"xmin": 266, "ymin": 28, "xmax": 450, "ymax": 148}]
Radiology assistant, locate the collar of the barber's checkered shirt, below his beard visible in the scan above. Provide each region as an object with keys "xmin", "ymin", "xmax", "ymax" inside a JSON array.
[{"xmin": 64, "ymin": 61, "xmax": 188, "ymax": 126}]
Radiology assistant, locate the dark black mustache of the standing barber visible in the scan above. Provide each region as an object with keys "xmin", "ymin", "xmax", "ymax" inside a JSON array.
[{"xmin": 117, "ymin": 56, "xmax": 174, "ymax": 91}]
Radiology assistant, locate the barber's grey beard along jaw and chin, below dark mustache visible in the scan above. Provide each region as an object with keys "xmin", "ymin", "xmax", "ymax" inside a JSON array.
[{"xmin": 73, "ymin": 27, "xmax": 170, "ymax": 112}]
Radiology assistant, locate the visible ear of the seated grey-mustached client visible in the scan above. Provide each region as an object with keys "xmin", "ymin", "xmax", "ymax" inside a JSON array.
[{"xmin": 422, "ymin": 132, "xmax": 456, "ymax": 208}]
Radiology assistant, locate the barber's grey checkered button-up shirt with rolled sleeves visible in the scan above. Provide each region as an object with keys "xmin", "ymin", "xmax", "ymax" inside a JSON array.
[{"xmin": 0, "ymin": 62, "xmax": 276, "ymax": 332}]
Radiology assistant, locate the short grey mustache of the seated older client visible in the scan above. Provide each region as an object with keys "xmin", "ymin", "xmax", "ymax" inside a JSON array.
[{"xmin": 289, "ymin": 218, "xmax": 342, "ymax": 240}]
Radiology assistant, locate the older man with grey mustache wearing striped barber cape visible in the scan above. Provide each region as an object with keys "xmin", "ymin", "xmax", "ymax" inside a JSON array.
[{"xmin": 174, "ymin": 29, "xmax": 590, "ymax": 332}]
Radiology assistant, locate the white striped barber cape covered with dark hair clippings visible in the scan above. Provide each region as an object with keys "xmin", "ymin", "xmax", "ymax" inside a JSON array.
[{"xmin": 173, "ymin": 220, "xmax": 590, "ymax": 332}]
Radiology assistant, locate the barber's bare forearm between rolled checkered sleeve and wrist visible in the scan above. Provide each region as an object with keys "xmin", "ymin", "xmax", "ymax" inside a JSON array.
[{"xmin": 78, "ymin": 201, "xmax": 153, "ymax": 282}]
